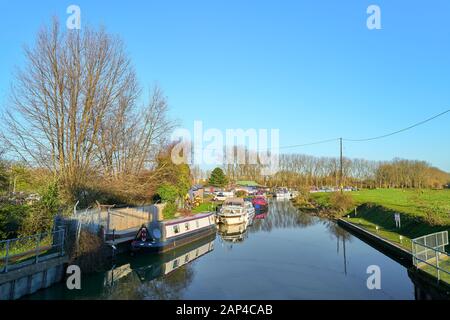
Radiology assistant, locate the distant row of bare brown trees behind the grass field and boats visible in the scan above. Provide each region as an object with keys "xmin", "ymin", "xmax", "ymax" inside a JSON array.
[{"xmin": 217, "ymin": 147, "xmax": 450, "ymax": 188}]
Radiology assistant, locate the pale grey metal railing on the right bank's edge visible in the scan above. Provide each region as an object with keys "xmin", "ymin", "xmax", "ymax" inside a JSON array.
[{"xmin": 412, "ymin": 231, "xmax": 450, "ymax": 280}]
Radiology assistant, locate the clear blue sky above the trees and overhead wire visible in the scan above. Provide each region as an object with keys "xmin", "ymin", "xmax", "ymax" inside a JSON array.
[{"xmin": 0, "ymin": 0, "xmax": 450, "ymax": 171}]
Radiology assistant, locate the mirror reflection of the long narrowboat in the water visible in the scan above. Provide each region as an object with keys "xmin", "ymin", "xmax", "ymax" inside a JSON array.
[{"xmin": 105, "ymin": 233, "xmax": 216, "ymax": 286}]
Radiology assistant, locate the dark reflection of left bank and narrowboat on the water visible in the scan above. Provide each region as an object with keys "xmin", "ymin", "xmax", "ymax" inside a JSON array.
[{"xmin": 26, "ymin": 234, "xmax": 216, "ymax": 300}]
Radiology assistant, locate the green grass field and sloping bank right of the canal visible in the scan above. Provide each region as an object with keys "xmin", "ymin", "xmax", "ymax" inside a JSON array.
[{"xmin": 312, "ymin": 189, "xmax": 450, "ymax": 283}]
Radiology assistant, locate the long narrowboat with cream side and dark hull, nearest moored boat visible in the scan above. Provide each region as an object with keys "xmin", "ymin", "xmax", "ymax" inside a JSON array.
[{"xmin": 131, "ymin": 213, "xmax": 216, "ymax": 252}]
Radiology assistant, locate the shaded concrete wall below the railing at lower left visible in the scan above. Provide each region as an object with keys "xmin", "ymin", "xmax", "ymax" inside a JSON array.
[{"xmin": 0, "ymin": 257, "xmax": 67, "ymax": 300}]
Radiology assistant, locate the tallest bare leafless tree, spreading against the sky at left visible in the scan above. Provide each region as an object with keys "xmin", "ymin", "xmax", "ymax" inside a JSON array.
[{"xmin": 4, "ymin": 20, "xmax": 139, "ymax": 198}]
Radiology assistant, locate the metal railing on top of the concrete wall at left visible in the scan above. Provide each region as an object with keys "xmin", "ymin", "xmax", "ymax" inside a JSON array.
[{"xmin": 0, "ymin": 228, "xmax": 65, "ymax": 273}]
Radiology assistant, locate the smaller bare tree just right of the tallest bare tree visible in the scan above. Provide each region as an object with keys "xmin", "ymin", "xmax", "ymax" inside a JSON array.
[{"xmin": 97, "ymin": 86, "xmax": 176, "ymax": 178}]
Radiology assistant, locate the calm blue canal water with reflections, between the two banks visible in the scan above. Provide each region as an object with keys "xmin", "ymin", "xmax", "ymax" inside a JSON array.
[{"xmin": 28, "ymin": 201, "xmax": 414, "ymax": 299}]
